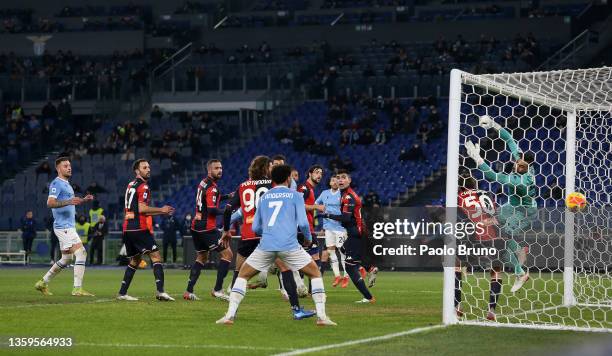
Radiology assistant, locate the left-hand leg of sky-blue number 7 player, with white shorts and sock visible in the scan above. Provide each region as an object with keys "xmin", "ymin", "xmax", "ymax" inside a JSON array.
[{"xmin": 217, "ymin": 248, "xmax": 276, "ymax": 324}]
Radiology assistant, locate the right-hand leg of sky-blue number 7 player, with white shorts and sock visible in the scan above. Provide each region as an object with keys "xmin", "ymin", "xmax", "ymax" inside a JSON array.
[{"xmin": 290, "ymin": 249, "xmax": 336, "ymax": 326}]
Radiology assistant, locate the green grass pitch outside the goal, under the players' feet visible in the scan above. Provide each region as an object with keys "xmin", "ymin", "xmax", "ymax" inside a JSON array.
[{"xmin": 0, "ymin": 268, "xmax": 609, "ymax": 356}]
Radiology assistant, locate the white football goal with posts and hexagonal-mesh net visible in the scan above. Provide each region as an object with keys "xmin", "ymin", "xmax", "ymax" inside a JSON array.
[{"xmin": 443, "ymin": 67, "xmax": 612, "ymax": 332}]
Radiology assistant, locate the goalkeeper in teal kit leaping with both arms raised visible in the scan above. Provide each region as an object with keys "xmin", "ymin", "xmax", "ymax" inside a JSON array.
[{"xmin": 465, "ymin": 115, "xmax": 538, "ymax": 293}]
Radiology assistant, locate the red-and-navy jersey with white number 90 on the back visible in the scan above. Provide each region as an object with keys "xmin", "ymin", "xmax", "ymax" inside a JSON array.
[{"xmin": 229, "ymin": 179, "xmax": 272, "ymax": 240}]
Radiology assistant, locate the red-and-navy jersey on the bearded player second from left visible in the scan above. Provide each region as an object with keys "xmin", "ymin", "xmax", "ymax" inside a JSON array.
[{"xmin": 123, "ymin": 177, "xmax": 152, "ymax": 231}]
